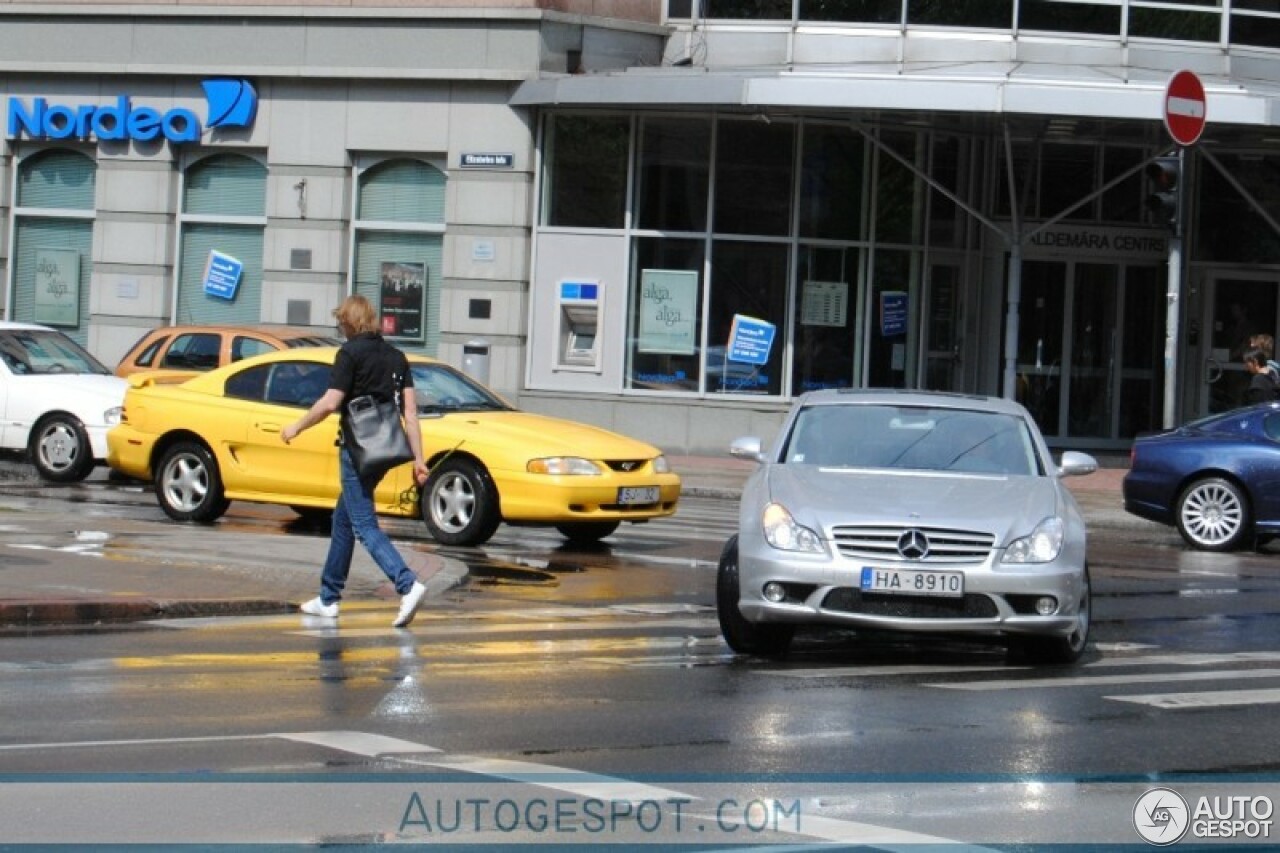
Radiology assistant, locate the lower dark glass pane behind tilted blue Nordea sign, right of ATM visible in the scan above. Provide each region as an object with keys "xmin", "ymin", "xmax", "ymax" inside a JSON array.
[{"xmin": 707, "ymin": 240, "xmax": 787, "ymax": 394}]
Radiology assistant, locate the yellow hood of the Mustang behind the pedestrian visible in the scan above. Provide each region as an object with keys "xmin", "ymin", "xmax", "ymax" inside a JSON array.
[{"xmin": 435, "ymin": 411, "xmax": 662, "ymax": 460}]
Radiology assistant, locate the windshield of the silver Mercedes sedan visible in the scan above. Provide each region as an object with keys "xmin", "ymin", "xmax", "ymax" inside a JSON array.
[{"xmin": 783, "ymin": 405, "xmax": 1042, "ymax": 475}]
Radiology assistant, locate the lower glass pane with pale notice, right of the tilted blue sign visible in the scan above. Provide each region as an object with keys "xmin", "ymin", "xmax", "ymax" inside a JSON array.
[{"xmin": 791, "ymin": 247, "xmax": 861, "ymax": 394}]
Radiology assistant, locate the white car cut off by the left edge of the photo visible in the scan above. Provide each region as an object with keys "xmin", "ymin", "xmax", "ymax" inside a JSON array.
[{"xmin": 0, "ymin": 320, "xmax": 129, "ymax": 483}]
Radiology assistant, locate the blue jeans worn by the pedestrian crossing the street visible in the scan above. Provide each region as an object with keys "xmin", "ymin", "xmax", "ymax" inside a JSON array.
[{"xmin": 320, "ymin": 447, "xmax": 417, "ymax": 605}]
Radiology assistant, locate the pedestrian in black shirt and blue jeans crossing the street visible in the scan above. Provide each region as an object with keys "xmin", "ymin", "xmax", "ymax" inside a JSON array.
[{"xmin": 280, "ymin": 296, "xmax": 426, "ymax": 628}]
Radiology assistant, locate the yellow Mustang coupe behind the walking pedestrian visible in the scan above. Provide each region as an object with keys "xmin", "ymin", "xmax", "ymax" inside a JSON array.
[{"xmin": 106, "ymin": 347, "xmax": 680, "ymax": 546}]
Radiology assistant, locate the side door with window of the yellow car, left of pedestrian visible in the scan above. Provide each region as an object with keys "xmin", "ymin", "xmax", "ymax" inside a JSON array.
[{"xmin": 225, "ymin": 361, "xmax": 338, "ymax": 503}]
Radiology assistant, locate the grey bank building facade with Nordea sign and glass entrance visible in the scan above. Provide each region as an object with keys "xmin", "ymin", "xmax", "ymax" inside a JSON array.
[{"xmin": 0, "ymin": 0, "xmax": 1280, "ymax": 453}]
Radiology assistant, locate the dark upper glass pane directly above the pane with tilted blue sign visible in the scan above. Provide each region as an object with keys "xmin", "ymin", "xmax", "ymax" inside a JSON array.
[{"xmin": 713, "ymin": 120, "xmax": 795, "ymax": 236}]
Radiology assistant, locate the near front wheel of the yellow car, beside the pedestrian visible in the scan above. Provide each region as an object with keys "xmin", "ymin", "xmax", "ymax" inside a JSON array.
[{"xmin": 421, "ymin": 459, "xmax": 502, "ymax": 546}]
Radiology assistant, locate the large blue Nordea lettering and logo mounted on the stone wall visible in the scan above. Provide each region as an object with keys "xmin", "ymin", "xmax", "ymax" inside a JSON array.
[{"xmin": 8, "ymin": 79, "xmax": 257, "ymax": 142}]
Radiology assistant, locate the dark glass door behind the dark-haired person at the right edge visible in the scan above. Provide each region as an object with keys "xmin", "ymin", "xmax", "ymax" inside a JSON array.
[{"xmin": 1199, "ymin": 274, "xmax": 1280, "ymax": 414}]
